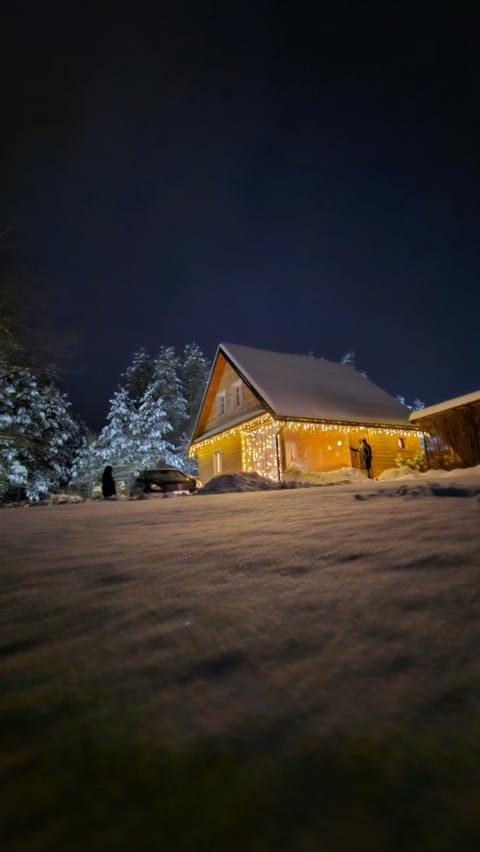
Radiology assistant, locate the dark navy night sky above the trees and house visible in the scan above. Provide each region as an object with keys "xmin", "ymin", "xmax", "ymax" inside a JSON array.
[{"xmin": 0, "ymin": 0, "xmax": 480, "ymax": 426}]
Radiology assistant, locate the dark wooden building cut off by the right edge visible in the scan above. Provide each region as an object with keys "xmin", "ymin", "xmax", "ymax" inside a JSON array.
[{"xmin": 410, "ymin": 391, "xmax": 480, "ymax": 468}]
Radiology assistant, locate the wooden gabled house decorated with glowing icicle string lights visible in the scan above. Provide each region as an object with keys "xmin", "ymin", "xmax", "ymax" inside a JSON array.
[{"xmin": 190, "ymin": 343, "xmax": 421, "ymax": 482}]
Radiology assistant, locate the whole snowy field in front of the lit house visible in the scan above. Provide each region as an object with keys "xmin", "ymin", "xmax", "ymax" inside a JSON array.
[{"xmin": 0, "ymin": 468, "xmax": 480, "ymax": 852}]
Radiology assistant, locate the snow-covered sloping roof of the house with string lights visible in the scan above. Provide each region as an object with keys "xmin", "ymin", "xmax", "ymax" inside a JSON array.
[{"xmin": 219, "ymin": 343, "xmax": 411, "ymax": 427}]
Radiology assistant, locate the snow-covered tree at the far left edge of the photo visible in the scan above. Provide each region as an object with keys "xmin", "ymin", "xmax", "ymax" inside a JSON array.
[{"xmin": 0, "ymin": 366, "xmax": 81, "ymax": 500}]
